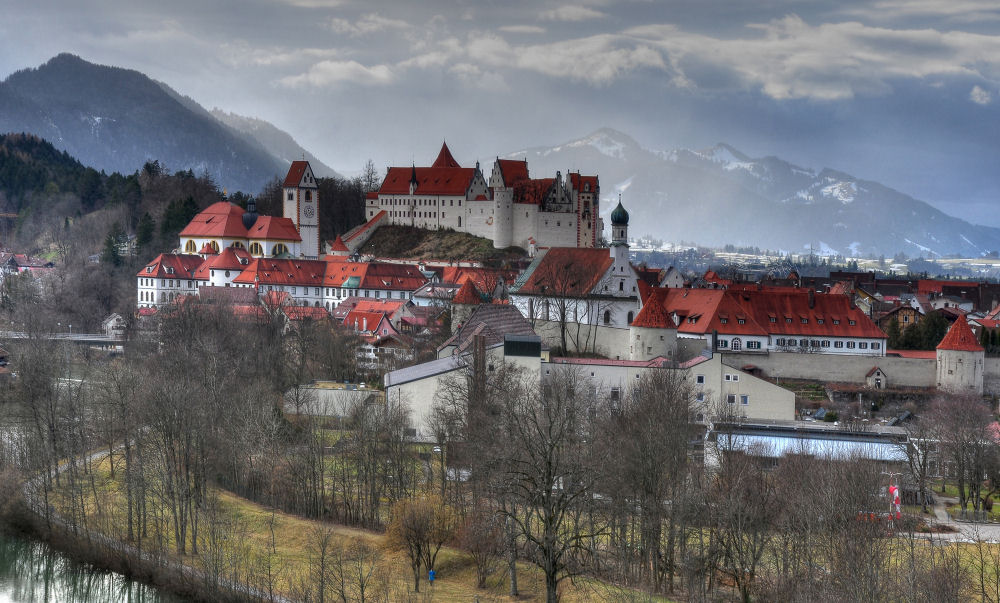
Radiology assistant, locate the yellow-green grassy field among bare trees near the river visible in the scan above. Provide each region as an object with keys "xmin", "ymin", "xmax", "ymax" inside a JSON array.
[{"xmin": 48, "ymin": 458, "xmax": 667, "ymax": 603}]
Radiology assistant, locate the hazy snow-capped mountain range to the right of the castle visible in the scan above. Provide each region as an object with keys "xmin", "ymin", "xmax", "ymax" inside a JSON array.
[{"xmin": 507, "ymin": 128, "xmax": 1000, "ymax": 257}]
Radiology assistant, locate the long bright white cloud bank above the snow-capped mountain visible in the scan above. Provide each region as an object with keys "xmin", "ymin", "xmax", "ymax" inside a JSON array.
[{"xmin": 625, "ymin": 15, "xmax": 1000, "ymax": 100}]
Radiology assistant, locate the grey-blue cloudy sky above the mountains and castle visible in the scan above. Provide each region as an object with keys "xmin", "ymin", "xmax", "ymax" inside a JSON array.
[{"xmin": 0, "ymin": 0, "xmax": 1000, "ymax": 226}]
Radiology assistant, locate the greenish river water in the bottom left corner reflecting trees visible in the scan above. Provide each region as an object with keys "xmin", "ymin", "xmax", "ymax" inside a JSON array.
[{"xmin": 0, "ymin": 529, "xmax": 184, "ymax": 603}]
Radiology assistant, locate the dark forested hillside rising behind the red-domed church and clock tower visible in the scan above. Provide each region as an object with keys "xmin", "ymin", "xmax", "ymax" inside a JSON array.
[{"xmin": 0, "ymin": 134, "xmax": 364, "ymax": 328}]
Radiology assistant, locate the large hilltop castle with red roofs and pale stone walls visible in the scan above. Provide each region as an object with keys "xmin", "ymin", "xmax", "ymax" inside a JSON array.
[{"xmin": 365, "ymin": 144, "xmax": 603, "ymax": 255}]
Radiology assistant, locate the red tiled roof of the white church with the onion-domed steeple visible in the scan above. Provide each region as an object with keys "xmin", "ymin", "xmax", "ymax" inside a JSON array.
[{"xmin": 518, "ymin": 247, "xmax": 614, "ymax": 296}]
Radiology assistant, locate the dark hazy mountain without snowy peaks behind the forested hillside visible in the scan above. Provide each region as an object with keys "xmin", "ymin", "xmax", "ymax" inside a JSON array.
[{"xmin": 0, "ymin": 54, "xmax": 328, "ymax": 194}]
